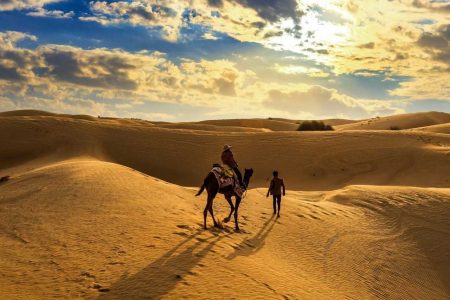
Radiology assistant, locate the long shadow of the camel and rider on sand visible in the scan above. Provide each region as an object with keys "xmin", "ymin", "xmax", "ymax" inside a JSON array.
[{"xmin": 98, "ymin": 231, "xmax": 226, "ymax": 299}]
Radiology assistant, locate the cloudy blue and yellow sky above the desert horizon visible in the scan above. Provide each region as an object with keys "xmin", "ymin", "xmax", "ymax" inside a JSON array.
[{"xmin": 0, "ymin": 0, "xmax": 450, "ymax": 122}]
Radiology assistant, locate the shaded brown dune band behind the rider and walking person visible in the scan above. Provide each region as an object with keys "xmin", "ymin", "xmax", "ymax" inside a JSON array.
[{"xmin": 0, "ymin": 113, "xmax": 450, "ymax": 190}]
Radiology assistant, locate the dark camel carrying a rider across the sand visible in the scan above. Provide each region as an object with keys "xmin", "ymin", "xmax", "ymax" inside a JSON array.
[{"xmin": 195, "ymin": 169, "xmax": 253, "ymax": 231}]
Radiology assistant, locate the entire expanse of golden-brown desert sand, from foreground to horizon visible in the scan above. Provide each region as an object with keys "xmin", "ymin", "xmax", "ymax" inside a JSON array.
[{"xmin": 0, "ymin": 111, "xmax": 450, "ymax": 299}]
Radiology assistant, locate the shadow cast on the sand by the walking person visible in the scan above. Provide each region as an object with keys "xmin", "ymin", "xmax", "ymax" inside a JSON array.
[{"xmin": 227, "ymin": 215, "xmax": 276, "ymax": 260}]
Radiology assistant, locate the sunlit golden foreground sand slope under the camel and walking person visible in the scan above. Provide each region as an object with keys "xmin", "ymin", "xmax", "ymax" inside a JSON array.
[{"xmin": 0, "ymin": 159, "xmax": 450, "ymax": 299}]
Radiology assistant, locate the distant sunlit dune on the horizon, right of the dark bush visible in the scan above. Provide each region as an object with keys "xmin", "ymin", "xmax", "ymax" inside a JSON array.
[{"xmin": 335, "ymin": 112, "xmax": 450, "ymax": 130}]
